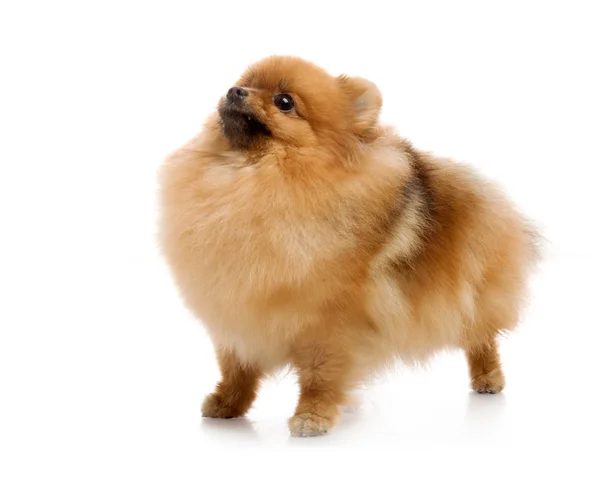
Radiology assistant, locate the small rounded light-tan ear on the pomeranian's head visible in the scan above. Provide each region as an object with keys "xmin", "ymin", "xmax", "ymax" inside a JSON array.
[{"xmin": 338, "ymin": 75, "xmax": 383, "ymax": 138}]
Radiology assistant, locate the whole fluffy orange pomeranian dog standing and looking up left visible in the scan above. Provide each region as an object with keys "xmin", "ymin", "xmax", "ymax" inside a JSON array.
[{"xmin": 160, "ymin": 56, "xmax": 537, "ymax": 436}]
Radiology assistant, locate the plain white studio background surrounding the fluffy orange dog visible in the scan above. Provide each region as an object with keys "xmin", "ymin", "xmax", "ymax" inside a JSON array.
[{"xmin": 0, "ymin": 0, "xmax": 600, "ymax": 481}]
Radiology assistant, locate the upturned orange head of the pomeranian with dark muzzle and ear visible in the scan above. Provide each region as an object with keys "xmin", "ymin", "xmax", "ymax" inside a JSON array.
[{"xmin": 219, "ymin": 56, "xmax": 382, "ymax": 150}]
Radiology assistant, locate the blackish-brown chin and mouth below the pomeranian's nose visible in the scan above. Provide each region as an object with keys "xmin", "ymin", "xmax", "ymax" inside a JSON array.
[{"xmin": 219, "ymin": 105, "xmax": 271, "ymax": 149}]
